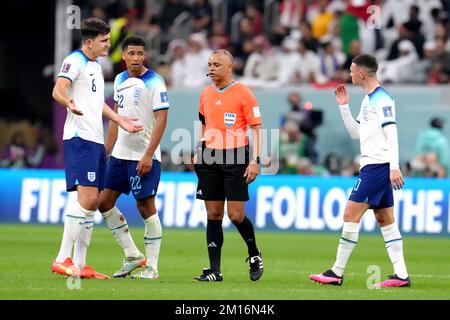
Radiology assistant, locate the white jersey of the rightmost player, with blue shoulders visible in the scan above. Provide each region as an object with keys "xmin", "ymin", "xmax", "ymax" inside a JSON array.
[{"xmin": 356, "ymin": 86, "xmax": 396, "ymax": 168}]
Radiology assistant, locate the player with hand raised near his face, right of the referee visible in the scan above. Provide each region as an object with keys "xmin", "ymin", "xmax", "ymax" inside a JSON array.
[{"xmin": 309, "ymin": 54, "xmax": 411, "ymax": 287}]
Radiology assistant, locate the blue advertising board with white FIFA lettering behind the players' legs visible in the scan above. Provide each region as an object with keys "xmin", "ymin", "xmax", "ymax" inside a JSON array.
[{"xmin": 0, "ymin": 169, "xmax": 450, "ymax": 236}]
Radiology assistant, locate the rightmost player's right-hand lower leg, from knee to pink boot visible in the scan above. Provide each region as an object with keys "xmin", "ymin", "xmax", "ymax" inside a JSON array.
[{"xmin": 374, "ymin": 207, "xmax": 411, "ymax": 287}]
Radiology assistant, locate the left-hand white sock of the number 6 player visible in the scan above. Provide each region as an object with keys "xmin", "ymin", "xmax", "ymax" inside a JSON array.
[{"xmin": 56, "ymin": 201, "xmax": 86, "ymax": 263}]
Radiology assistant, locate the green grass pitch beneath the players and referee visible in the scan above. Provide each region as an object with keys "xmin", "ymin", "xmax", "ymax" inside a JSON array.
[{"xmin": 0, "ymin": 224, "xmax": 450, "ymax": 300}]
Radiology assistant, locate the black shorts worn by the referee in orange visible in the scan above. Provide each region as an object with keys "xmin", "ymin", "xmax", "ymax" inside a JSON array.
[{"xmin": 194, "ymin": 146, "xmax": 249, "ymax": 201}]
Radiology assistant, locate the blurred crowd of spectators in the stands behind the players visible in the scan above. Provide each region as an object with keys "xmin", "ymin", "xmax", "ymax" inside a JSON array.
[{"xmin": 75, "ymin": 0, "xmax": 450, "ymax": 88}]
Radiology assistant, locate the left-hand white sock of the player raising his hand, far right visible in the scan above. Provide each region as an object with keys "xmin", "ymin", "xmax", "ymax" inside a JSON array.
[{"xmin": 331, "ymin": 222, "xmax": 359, "ymax": 277}]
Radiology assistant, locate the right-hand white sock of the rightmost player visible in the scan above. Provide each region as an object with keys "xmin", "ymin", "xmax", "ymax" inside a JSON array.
[{"xmin": 381, "ymin": 222, "xmax": 408, "ymax": 279}]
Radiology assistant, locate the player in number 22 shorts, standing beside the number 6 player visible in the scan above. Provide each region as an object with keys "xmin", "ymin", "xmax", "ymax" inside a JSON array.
[{"xmin": 99, "ymin": 36, "xmax": 169, "ymax": 279}]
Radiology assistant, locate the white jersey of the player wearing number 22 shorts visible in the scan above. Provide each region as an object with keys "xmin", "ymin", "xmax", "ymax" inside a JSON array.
[{"xmin": 111, "ymin": 69, "xmax": 169, "ymax": 162}]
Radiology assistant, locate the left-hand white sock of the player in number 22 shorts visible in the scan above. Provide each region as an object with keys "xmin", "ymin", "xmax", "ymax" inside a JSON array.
[{"xmin": 102, "ymin": 206, "xmax": 142, "ymax": 257}]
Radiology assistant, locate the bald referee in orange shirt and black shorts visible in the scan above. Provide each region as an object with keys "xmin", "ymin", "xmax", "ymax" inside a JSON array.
[{"xmin": 194, "ymin": 50, "xmax": 263, "ymax": 281}]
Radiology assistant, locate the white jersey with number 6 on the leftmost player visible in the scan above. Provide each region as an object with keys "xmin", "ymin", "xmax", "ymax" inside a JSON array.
[{"xmin": 58, "ymin": 50, "xmax": 105, "ymax": 144}]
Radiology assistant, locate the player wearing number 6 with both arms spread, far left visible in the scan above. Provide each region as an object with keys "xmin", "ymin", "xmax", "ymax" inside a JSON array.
[{"xmin": 51, "ymin": 18, "xmax": 142, "ymax": 279}]
